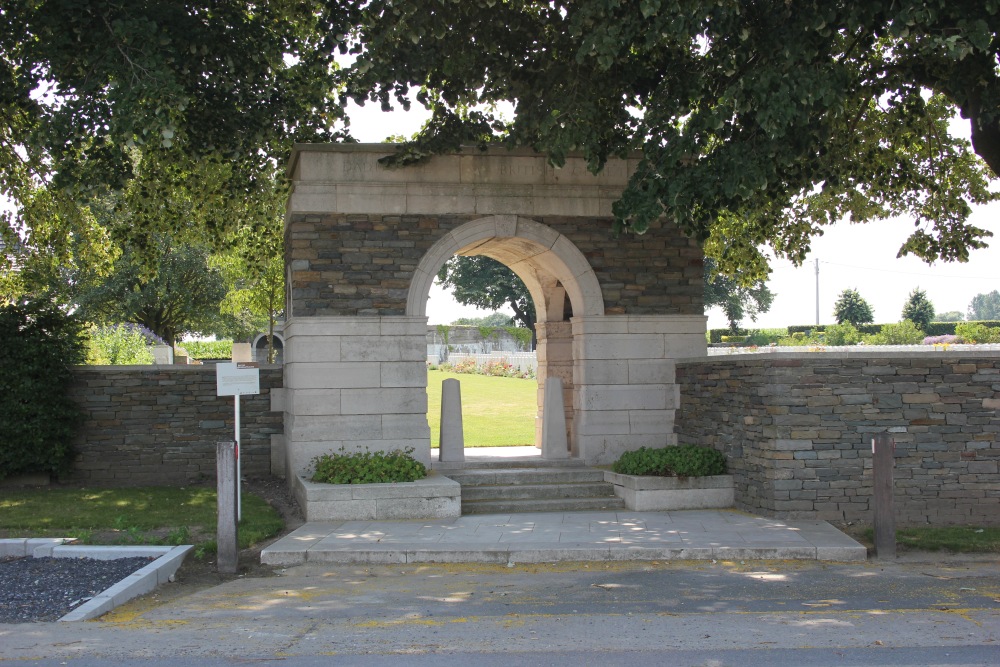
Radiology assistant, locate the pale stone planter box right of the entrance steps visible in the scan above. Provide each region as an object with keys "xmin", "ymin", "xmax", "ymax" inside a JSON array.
[{"xmin": 604, "ymin": 470, "xmax": 735, "ymax": 512}]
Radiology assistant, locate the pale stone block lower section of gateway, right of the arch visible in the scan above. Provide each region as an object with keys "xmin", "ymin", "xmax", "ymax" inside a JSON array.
[{"xmin": 572, "ymin": 315, "xmax": 707, "ymax": 465}]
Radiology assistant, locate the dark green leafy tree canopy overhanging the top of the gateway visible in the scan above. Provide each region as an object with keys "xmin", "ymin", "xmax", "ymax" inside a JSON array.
[{"xmin": 0, "ymin": 0, "xmax": 1000, "ymax": 283}]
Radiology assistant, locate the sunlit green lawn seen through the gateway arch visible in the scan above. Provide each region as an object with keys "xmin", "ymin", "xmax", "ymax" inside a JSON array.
[{"xmin": 427, "ymin": 370, "xmax": 538, "ymax": 447}]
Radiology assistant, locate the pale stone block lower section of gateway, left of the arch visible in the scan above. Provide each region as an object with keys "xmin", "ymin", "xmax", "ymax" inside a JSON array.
[{"xmin": 284, "ymin": 316, "xmax": 430, "ymax": 479}]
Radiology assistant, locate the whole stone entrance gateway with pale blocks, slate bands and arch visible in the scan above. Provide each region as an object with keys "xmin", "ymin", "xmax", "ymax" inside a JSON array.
[{"xmin": 285, "ymin": 144, "xmax": 706, "ymax": 475}]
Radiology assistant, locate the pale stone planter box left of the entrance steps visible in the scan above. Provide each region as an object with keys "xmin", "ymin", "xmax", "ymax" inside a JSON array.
[{"xmin": 293, "ymin": 472, "xmax": 462, "ymax": 521}]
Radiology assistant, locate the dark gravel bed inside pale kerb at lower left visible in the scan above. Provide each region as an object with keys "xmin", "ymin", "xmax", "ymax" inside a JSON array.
[{"xmin": 0, "ymin": 556, "xmax": 156, "ymax": 623}]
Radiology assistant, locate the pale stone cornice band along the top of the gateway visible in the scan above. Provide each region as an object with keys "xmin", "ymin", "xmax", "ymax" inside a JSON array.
[{"xmin": 288, "ymin": 144, "xmax": 639, "ymax": 217}]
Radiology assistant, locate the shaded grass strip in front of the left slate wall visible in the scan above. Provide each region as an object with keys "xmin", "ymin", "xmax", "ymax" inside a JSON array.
[{"xmin": 0, "ymin": 486, "xmax": 284, "ymax": 555}]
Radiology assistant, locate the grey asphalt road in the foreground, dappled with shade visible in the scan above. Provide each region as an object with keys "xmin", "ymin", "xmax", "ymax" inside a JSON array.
[{"xmin": 0, "ymin": 559, "xmax": 1000, "ymax": 667}]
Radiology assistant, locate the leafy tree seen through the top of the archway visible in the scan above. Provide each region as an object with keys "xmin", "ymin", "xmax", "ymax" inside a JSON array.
[{"xmin": 437, "ymin": 255, "xmax": 535, "ymax": 331}]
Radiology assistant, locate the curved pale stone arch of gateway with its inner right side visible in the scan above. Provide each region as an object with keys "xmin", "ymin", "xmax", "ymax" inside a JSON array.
[{"xmin": 406, "ymin": 216, "xmax": 604, "ymax": 454}]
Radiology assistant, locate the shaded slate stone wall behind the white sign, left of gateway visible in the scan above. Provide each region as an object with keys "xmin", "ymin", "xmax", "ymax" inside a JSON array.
[{"xmin": 70, "ymin": 364, "xmax": 283, "ymax": 486}]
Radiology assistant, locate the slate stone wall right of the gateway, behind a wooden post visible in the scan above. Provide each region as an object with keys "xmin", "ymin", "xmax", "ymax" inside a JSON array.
[{"xmin": 675, "ymin": 351, "xmax": 1000, "ymax": 525}]
